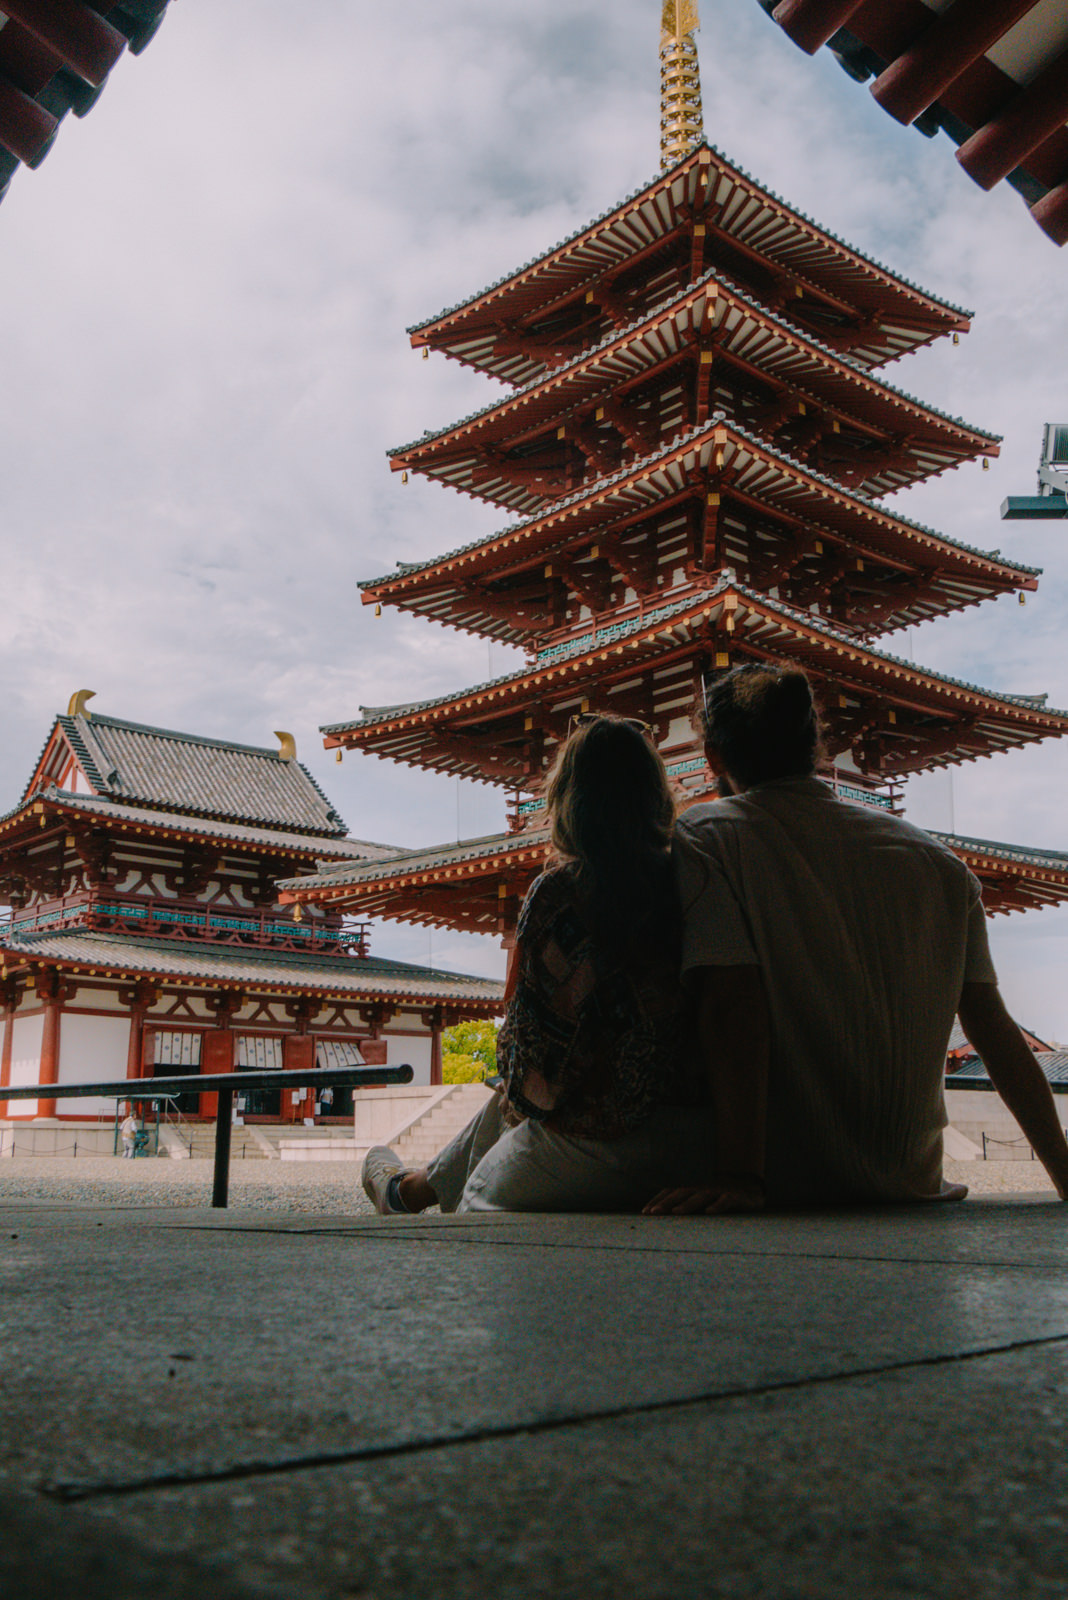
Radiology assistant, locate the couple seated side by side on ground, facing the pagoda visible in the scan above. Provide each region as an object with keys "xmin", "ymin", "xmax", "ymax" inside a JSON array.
[{"xmin": 363, "ymin": 666, "xmax": 1068, "ymax": 1214}]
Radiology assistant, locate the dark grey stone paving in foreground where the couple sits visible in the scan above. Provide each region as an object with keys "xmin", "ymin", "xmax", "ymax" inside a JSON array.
[{"xmin": 0, "ymin": 1184, "xmax": 1068, "ymax": 1600}]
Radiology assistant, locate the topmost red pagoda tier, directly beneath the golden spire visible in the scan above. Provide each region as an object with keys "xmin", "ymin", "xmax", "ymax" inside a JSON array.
[{"xmin": 409, "ymin": 141, "xmax": 970, "ymax": 384}]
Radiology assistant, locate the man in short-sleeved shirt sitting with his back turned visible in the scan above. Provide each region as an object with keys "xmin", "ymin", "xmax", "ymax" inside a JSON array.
[{"xmin": 646, "ymin": 666, "xmax": 1068, "ymax": 1214}]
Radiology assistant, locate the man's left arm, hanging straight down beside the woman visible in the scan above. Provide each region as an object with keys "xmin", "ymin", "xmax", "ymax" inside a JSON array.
[{"xmin": 644, "ymin": 966, "xmax": 771, "ymax": 1216}]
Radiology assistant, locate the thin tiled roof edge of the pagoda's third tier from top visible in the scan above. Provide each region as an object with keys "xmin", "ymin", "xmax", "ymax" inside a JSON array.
[{"xmin": 358, "ymin": 411, "xmax": 1041, "ymax": 605}]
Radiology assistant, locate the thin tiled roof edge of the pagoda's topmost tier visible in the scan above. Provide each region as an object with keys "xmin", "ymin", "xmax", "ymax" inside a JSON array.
[{"xmin": 408, "ymin": 141, "xmax": 972, "ymax": 356}]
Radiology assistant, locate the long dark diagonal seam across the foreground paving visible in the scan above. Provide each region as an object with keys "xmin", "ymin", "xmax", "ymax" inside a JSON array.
[{"xmin": 37, "ymin": 1333, "xmax": 1068, "ymax": 1504}]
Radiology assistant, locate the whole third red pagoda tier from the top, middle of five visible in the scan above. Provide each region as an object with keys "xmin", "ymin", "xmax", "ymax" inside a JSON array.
[{"xmin": 369, "ymin": 414, "xmax": 1038, "ymax": 648}]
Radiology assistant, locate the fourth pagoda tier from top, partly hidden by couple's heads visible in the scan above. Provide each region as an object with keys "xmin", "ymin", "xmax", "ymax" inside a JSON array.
[{"xmin": 321, "ymin": 573, "xmax": 1068, "ymax": 794}]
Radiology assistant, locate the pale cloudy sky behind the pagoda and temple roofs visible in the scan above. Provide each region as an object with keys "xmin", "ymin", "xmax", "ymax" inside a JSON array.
[{"xmin": 0, "ymin": 0, "xmax": 1068, "ymax": 1040}]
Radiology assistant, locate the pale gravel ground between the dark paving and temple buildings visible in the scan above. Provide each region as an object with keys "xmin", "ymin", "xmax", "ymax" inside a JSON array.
[{"xmin": 0, "ymin": 1155, "xmax": 1054, "ymax": 1216}]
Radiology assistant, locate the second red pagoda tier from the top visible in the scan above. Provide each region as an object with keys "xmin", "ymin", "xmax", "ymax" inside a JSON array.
[{"xmin": 390, "ymin": 269, "xmax": 998, "ymax": 515}]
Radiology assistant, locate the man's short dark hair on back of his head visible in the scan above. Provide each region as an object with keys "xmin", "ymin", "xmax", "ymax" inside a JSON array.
[{"xmin": 700, "ymin": 662, "xmax": 822, "ymax": 789}]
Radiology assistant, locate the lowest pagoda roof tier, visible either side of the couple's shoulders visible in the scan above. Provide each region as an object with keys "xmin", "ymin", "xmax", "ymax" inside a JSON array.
[{"xmin": 280, "ymin": 819, "xmax": 1068, "ymax": 941}]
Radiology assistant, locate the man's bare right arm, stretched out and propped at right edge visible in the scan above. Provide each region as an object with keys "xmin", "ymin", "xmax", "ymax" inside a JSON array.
[{"xmin": 958, "ymin": 982, "xmax": 1068, "ymax": 1200}]
